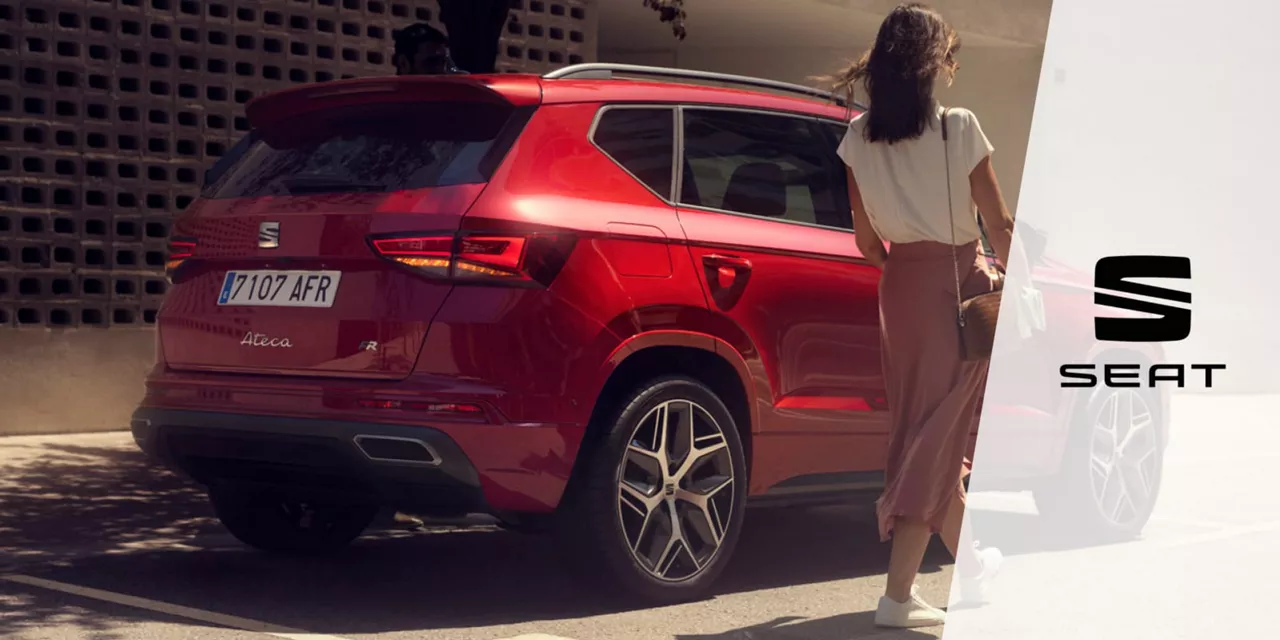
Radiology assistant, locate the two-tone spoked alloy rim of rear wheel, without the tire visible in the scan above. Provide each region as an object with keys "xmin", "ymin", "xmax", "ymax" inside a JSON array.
[{"xmin": 617, "ymin": 399, "xmax": 737, "ymax": 582}]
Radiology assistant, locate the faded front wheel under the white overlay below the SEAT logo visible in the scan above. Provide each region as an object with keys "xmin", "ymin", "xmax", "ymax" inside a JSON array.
[{"xmin": 1033, "ymin": 388, "xmax": 1164, "ymax": 541}]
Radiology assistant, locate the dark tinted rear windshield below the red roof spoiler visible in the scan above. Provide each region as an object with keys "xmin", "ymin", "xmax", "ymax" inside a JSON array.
[{"xmin": 204, "ymin": 102, "xmax": 512, "ymax": 198}]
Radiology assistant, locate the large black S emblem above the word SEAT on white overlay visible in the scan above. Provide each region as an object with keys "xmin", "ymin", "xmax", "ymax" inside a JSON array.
[{"xmin": 1093, "ymin": 256, "xmax": 1192, "ymax": 342}]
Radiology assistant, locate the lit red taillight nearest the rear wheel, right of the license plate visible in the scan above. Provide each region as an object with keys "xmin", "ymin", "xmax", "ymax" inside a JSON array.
[{"xmin": 369, "ymin": 232, "xmax": 576, "ymax": 287}]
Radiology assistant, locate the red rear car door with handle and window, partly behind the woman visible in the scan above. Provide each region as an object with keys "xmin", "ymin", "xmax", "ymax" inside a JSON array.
[{"xmin": 677, "ymin": 106, "xmax": 886, "ymax": 488}]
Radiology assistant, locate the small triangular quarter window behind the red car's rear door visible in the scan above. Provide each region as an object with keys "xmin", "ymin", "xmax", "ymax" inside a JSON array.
[{"xmin": 591, "ymin": 106, "xmax": 676, "ymax": 200}]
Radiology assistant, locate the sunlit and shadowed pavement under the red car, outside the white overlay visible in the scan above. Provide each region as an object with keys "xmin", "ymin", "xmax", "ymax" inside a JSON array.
[{"xmin": 0, "ymin": 434, "xmax": 950, "ymax": 640}]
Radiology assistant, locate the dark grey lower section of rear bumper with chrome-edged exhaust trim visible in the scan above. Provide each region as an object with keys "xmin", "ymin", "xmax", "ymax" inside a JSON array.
[{"xmin": 132, "ymin": 408, "xmax": 490, "ymax": 516}]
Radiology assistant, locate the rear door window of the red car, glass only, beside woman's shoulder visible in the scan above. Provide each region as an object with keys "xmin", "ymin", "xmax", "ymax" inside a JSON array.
[{"xmin": 680, "ymin": 109, "xmax": 854, "ymax": 230}]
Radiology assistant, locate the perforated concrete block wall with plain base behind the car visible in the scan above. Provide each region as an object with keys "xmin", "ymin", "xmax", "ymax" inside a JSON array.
[{"xmin": 0, "ymin": 0, "xmax": 598, "ymax": 434}]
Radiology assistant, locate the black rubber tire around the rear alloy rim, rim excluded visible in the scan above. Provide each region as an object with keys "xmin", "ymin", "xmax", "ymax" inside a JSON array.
[{"xmin": 558, "ymin": 376, "xmax": 748, "ymax": 604}]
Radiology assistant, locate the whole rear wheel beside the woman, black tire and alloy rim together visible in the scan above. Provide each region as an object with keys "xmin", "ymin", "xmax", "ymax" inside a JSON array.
[{"xmin": 554, "ymin": 376, "xmax": 746, "ymax": 604}]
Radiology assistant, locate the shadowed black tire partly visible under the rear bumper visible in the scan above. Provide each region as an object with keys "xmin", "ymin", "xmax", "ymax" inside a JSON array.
[{"xmin": 209, "ymin": 488, "xmax": 378, "ymax": 554}]
